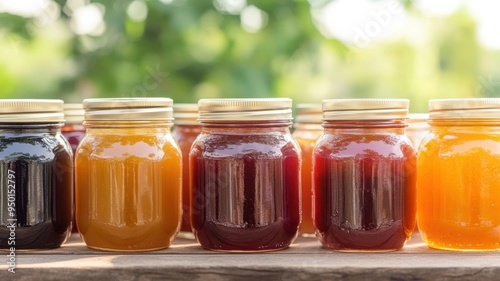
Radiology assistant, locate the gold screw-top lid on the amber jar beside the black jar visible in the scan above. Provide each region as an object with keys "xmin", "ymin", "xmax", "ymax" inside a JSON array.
[{"xmin": 83, "ymin": 98, "xmax": 173, "ymax": 121}]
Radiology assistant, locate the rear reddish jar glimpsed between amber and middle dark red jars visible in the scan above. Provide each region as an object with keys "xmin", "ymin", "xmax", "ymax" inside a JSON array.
[{"xmin": 172, "ymin": 103, "xmax": 201, "ymax": 236}]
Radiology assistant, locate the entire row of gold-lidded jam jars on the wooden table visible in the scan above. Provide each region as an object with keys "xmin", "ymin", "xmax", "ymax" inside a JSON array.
[{"xmin": 0, "ymin": 98, "xmax": 500, "ymax": 251}]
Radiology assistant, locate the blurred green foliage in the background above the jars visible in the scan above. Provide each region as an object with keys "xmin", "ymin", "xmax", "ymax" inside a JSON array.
[{"xmin": 0, "ymin": 0, "xmax": 500, "ymax": 111}]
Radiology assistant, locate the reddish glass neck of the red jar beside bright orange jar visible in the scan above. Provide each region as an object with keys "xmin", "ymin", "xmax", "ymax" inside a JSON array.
[{"xmin": 323, "ymin": 119, "xmax": 408, "ymax": 134}]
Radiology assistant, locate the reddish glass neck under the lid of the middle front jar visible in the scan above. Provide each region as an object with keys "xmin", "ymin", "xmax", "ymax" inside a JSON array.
[{"xmin": 200, "ymin": 121, "xmax": 292, "ymax": 135}]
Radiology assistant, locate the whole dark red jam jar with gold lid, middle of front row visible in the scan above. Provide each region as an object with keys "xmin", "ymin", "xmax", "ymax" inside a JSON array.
[{"xmin": 190, "ymin": 98, "xmax": 301, "ymax": 251}]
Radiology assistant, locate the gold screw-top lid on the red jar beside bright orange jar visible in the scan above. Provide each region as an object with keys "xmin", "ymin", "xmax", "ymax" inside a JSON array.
[{"xmin": 323, "ymin": 99, "xmax": 410, "ymax": 121}]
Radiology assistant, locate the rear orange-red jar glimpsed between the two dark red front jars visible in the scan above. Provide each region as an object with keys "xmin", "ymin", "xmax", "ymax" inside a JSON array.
[{"xmin": 292, "ymin": 104, "xmax": 323, "ymax": 236}]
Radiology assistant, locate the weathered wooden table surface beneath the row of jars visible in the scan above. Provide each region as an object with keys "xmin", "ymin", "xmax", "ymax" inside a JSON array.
[{"xmin": 0, "ymin": 231, "xmax": 500, "ymax": 281}]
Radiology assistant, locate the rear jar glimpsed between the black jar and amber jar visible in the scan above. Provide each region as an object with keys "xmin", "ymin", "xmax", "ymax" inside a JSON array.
[{"xmin": 61, "ymin": 103, "xmax": 85, "ymax": 233}]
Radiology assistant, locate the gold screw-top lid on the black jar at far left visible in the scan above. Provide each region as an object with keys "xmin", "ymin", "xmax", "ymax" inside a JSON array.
[{"xmin": 0, "ymin": 99, "xmax": 64, "ymax": 123}]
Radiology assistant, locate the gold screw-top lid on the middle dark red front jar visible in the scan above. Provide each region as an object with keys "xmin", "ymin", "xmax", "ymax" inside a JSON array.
[{"xmin": 198, "ymin": 98, "xmax": 292, "ymax": 122}]
